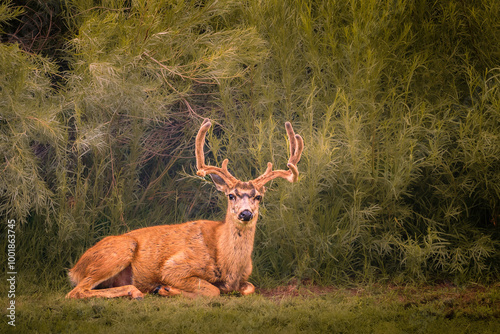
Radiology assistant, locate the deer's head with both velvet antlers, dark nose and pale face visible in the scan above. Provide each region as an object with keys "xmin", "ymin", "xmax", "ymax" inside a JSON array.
[{"xmin": 196, "ymin": 119, "xmax": 304, "ymax": 225}]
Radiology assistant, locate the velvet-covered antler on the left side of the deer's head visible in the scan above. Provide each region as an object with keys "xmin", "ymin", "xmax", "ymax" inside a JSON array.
[{"xmin": 195, "ymin": 118, "xmax": 238, "ymax": 187}]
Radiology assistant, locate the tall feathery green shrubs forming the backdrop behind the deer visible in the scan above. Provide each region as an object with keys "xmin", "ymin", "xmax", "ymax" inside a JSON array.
[{"xmin": 0, "ymin": 0, "xmax": 500, "ymax": 287}]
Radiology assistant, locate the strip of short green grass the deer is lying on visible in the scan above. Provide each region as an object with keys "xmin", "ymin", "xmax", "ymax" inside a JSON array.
[{"xmin": 0, "ymin": 284, "xmax": 500, "ymax": 334}]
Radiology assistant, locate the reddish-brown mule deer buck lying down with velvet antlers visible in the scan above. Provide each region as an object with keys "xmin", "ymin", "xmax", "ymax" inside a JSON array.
[{"xmin": 66, "ymin": 119, "xmax": 304, "ymax": 299}]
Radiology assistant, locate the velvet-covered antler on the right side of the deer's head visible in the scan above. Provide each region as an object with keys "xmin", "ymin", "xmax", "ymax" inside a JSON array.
[{"xmin": 251, "ymin": 122, "xmax": 304, "ymax": 188}]
